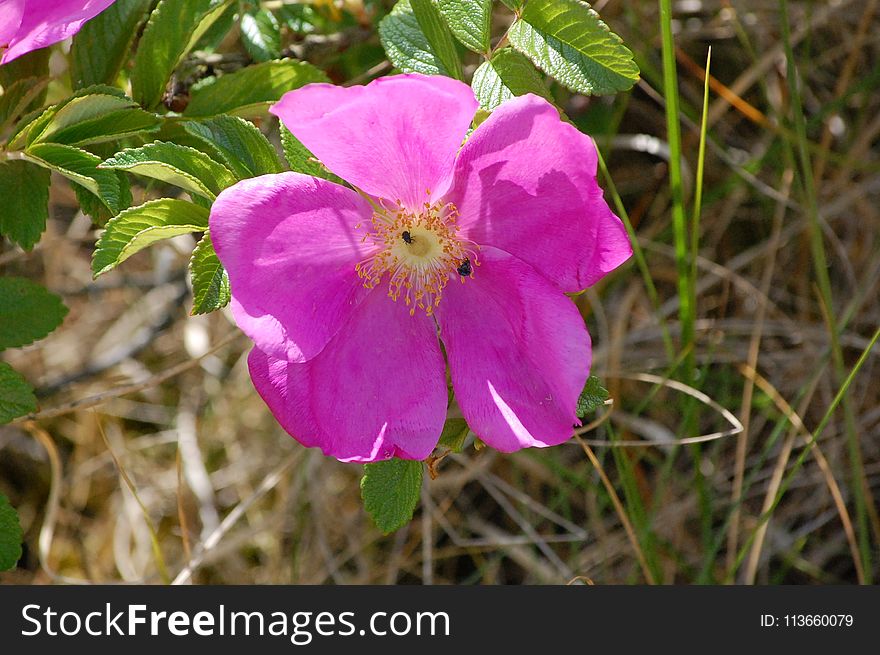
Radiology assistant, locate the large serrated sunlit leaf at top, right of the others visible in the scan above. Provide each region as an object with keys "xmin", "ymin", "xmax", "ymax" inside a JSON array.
[{"xmin": 507, "ymin": 0, "xmax": 639, "ymax": 95}]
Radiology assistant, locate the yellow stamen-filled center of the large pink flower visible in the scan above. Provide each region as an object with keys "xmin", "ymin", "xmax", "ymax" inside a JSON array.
[{"xmin": 355, "ymin": 200, "xmax": 480, "ymax": 316}]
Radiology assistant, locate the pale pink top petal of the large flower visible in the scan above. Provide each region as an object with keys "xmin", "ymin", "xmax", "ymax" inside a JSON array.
[{"xmin": 270, "ymin": 74, "xmax": 477, "ymax": 209}]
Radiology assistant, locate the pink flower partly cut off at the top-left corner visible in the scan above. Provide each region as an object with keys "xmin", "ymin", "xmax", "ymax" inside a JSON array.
[{"xmin": 0, "ymin": 0, "xmax": 114, "ymax": 64}]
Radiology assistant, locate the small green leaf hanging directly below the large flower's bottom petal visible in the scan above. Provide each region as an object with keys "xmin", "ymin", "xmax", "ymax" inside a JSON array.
[{"xmin": 361, "ymin": 458, "xmax": 422, "ymax": 534}]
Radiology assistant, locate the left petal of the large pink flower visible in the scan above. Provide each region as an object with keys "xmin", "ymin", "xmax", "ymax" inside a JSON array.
[{"xmin": 210, "ymin": 173, "xmax": 372, "ymax": 362}]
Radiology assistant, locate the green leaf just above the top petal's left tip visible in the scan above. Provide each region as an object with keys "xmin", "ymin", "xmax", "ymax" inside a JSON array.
[{"xmin": 183, "ymin": 59, "xmax": 330, "ymax": 116}]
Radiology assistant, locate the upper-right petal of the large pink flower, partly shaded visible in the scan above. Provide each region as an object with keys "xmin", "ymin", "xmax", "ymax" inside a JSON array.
[{"xmin": 447, "ymin": 95, "xmax": 632, "ymax": 292}]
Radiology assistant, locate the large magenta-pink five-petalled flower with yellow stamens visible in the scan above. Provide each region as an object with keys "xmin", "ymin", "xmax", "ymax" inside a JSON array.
[{"xmin": 210, "ymin": 75, "xmax": 632, "ymax": 462}]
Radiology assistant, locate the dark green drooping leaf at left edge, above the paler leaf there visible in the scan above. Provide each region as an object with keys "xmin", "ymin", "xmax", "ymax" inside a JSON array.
[{"xmin": 0, "ymin": 159, "xmax": 49, "ymax": 250}]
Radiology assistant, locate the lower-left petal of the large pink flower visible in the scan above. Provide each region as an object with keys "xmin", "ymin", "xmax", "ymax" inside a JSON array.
[{"xmin": 248, "ymin": 289, "xmax": 447, "ymax": 462}]
